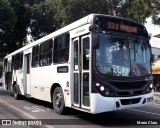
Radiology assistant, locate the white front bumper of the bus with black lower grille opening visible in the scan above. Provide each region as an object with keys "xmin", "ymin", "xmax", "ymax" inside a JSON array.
[{"xmin": 90, "ymin": 90, "xmax": 154, "ymax": 114}]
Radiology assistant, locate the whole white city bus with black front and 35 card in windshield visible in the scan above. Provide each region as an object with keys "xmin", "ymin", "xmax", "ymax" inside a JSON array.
[{"xmin": 2, "ymin": 14, "xmax": 154, "ymax": 114}]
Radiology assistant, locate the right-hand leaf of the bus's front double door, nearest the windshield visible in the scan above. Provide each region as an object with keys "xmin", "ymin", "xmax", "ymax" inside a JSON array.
[{"xmin": 80, "ymin": 35, "xmax": 91, "ymax": 109}]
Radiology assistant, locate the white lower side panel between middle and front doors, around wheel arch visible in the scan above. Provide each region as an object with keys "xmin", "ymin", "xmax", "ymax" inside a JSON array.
[{"xmin": 31, "ymin": 64, "xmax": 71, "ymax": 106}]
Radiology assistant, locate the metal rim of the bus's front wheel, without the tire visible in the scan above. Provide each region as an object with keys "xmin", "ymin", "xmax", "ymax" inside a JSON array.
[{"xmin": 54, "ymin": 92, "xmax": 62, "ymax": 109}]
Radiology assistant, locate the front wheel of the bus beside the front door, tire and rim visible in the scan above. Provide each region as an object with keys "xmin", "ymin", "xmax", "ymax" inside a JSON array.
[{"xmin": 52, "ymin": 87, "xmax": 66, "ymax": 114}]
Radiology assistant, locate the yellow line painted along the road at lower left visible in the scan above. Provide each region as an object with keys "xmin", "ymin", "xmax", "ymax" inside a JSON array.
[{"xmin": 0, "ymin": 99, "xmax": 55, "ymax": 128}]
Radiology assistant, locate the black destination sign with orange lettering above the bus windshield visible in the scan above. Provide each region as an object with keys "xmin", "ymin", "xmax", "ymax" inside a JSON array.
[{"xmin": 94, "ymin": 16, "xmax": 148, "ymax": 37}]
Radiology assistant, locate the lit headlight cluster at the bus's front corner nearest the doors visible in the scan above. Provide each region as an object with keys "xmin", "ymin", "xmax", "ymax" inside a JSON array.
[{"xmin": 95, "ymin": 83, "xmax": 114, "ymax": 96}]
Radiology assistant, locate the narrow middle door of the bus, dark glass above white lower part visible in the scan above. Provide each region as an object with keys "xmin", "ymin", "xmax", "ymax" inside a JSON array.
[{"xmin": 24, "ymin": 53, "xmax": 31, "ymax": 95}]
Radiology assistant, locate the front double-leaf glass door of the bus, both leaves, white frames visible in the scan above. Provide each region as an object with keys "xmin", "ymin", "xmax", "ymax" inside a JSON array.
[{"xmin": 73, "ymin": 36, "xmax": 90, "ymax": 109}]
